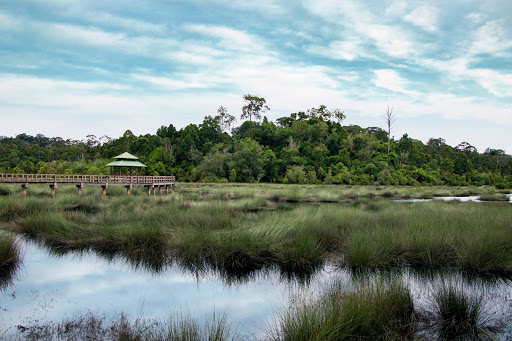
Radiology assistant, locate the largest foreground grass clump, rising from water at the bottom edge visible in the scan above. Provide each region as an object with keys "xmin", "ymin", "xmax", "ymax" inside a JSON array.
[{"xmin": 269, "ymin": 280, "xmax": 416, "ymax": 341}]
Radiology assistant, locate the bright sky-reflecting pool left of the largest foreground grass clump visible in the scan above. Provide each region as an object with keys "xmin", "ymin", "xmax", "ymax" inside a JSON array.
[{"xmin": 0, "ymin": 241, "xmax": 336, "ymax": 338}]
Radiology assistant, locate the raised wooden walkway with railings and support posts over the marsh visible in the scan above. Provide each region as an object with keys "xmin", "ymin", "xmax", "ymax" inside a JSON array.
[{"xmin": 0, "ymin": 173, "xmax": 176, "ymax": 196}]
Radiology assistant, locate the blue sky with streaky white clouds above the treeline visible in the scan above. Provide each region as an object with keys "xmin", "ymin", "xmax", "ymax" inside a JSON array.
[{"xmin": 0, "ymin": 0, "xmax": 512, "ymax": 154}]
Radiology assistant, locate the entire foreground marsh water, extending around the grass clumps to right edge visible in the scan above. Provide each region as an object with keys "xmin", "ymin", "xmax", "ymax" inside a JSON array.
[{"xmin": 0, "ymin": 236, "xmax": 512, "ymax": 339}]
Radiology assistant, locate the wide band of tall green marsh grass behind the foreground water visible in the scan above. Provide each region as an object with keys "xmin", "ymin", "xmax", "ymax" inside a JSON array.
[{"xmin": 0, "ymin": 187, "xmax": 512, "ymax": 273}]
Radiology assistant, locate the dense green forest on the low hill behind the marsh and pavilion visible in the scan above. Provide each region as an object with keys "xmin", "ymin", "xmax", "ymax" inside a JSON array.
[{"xmin": 0, "ymin": 106, "xmax": 512, "ymax": 188}]
